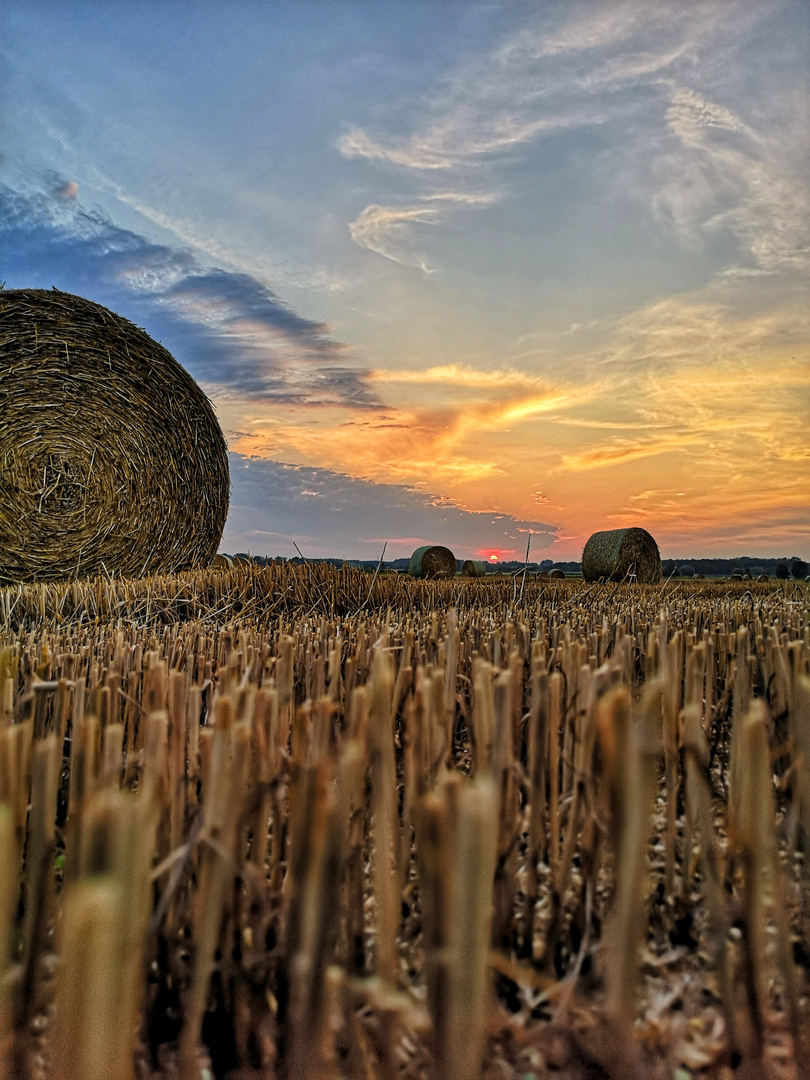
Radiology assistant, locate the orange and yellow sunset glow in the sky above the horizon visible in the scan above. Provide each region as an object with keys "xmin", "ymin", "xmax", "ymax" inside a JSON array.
[{"xmin": 220, "ymin": 286, "xmax": 810, "ymax": 563}]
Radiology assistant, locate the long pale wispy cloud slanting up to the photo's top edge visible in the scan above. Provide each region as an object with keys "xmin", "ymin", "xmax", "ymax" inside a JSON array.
[{"xmin": 338, "ymin": 0, "xmax": 731, "ymax": 172}]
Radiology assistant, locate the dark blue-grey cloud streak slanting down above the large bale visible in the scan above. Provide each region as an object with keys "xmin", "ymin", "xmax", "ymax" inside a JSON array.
[{"xmin": 0, "ymin": 180, "xmax": 379, "ymax": 408}]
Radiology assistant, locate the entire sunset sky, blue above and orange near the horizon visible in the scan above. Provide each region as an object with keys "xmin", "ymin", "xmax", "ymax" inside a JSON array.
[{"xmin": 0, "ymin": 0, "xmax": 810, "ymax": 561}]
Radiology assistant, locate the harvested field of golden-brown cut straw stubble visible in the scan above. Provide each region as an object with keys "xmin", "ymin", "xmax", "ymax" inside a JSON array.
[{"xmin": 0, "ymin": 564, "xmax": 810, "ymax": 1080}]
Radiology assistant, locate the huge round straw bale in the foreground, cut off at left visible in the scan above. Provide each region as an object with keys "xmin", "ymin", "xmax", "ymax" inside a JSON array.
[{"xmin": 0, "ymin": 289, "xmax": 229, "ymax": 581}]
